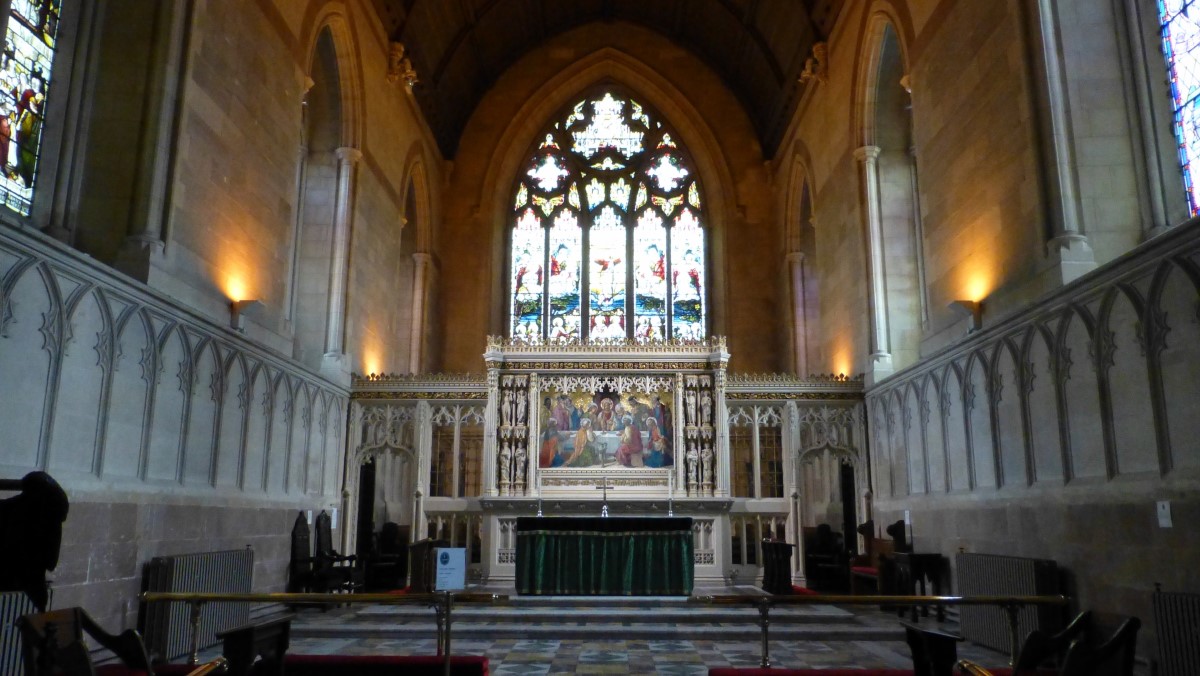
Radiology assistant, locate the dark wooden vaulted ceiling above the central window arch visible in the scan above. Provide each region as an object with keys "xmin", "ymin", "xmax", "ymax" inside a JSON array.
[{"xmin": 372, "ymin": 0, "xmax": 845, "ymax": 157}]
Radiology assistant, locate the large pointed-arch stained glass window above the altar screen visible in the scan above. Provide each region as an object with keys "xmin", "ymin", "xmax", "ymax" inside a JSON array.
[{"xmin": 509, "ymin": 90, "xmax": 708, "ymax": 343}]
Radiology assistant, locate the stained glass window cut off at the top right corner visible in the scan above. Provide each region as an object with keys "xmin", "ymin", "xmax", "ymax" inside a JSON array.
[{"xmin": 1158, "ymin": 0, "xmax": 1200, "ymax": 216}]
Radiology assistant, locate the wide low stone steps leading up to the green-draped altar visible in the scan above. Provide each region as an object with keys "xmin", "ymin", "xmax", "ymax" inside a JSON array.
[{"xmin": 292, "ymin": 597, "xmax": 904, "ymax": 641}]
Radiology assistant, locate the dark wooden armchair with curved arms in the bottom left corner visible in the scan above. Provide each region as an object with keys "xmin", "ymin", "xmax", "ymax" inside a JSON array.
[{"xmin": 17, "ymin": 608, "xmax": 226, "ymax": 676}]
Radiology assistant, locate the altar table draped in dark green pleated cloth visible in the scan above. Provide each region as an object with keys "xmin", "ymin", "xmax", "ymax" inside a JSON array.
[{"xmin": 516, "ymin": 516, "xmax": 694, "ymax": 596}]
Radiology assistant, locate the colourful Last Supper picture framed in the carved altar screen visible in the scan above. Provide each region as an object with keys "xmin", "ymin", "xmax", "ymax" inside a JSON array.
[{"xmin": 538, "ymin": 390, "xmax": 674, "ymax": 468}]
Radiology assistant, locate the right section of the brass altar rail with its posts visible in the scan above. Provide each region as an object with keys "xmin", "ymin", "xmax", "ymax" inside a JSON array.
[{"xmin": 689, "ymin": 594, "xmax": 1069, "ymax": 668}]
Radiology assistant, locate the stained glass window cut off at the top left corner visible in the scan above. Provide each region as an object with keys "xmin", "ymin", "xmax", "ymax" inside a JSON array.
[{"xmin": 0, "ymin": 0, "xmax": 61, "ymax": 216}]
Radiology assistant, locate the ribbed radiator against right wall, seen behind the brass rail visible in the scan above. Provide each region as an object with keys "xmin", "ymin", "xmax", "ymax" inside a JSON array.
[{"xmin": 954, "ymin": 554, "xmax": 1062, "ymax": 653}]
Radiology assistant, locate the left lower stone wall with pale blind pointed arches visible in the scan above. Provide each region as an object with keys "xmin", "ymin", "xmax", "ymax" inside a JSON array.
[{"xmin": 0, "ymin": 228, "xmax": 348, "ymax": 629}]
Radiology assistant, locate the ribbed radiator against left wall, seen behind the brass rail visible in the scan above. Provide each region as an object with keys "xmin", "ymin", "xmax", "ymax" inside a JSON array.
[{"xmin": 138, "ymin": 546, "xmax": 254, "ymax": 660}]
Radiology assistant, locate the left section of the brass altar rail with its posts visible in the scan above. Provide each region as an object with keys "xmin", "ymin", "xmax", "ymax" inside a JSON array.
[{"xmin": 138, "ymin": 592, "xmax": 508, "ymax": 676}]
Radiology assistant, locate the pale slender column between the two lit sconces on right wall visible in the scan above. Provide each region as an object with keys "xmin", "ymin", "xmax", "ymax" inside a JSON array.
[{"xmin": 854, "ymin": 145, "xmax": 892, "ymax": 382}]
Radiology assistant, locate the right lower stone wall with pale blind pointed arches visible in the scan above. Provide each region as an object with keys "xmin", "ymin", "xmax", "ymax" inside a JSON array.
[{"xmin": 868, "ymin": 221, "xmax": 1200, "ymax": 648}]
